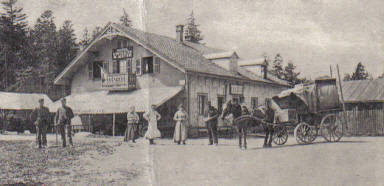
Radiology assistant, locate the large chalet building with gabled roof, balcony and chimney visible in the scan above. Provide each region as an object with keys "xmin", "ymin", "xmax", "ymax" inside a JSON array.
[{"xmin": 51, "ymin": 23, "xmax": 289, "ymax": 135}]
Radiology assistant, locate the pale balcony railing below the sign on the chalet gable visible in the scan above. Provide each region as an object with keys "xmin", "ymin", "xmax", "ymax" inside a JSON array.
[{"xmin": 101, "ymin": 73, "xmax": 136, "ymax": 90}]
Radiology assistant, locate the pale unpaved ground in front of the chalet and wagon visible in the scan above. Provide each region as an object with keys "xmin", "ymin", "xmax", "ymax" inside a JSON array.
[{"xmin": 0, "ymin": 135, "xmax": 384, "ymax": 185}]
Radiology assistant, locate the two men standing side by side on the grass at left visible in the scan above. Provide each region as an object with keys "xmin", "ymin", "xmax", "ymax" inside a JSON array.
[{"xmin": 30, "ymin": 98, "xmax": 74, "ymax": 148}]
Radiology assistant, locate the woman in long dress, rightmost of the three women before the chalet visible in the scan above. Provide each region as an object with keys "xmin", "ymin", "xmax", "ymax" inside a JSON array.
[{"xmin": 173, "ymin": 105, "xmax": 188, "ymax": 145}]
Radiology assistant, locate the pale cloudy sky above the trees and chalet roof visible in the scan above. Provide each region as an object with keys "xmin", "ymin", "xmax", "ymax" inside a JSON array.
[{"xmin": 18, "ymin": 0, "xmax": 384, "ymax": 79}]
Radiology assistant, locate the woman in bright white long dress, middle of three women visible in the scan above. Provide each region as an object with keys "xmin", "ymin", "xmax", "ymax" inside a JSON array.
[{"xmin": 143, "ymin": 105, "xmax": 161, "ymax": 145}]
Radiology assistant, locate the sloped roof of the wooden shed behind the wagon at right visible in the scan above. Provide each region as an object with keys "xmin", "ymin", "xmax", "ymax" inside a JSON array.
[{"xmin": 342, "ymin": 79, "xmax": 384, "ymax": 103}]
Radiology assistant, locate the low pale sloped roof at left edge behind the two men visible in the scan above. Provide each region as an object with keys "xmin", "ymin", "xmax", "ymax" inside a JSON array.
[{"xmin": 0, "ymin": 92, "xmax": 52, "ymax": 110}]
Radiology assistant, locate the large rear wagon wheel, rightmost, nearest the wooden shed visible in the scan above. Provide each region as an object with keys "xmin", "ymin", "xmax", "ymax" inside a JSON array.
[{"xmin": 320, "ymin": 114, "xmax": 343, "ymax": 142}]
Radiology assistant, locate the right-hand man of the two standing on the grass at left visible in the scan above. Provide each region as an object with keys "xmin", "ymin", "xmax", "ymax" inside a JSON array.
[{"xmin": 55, "ymin": 98, "xmax": 74, "ymax": 147}]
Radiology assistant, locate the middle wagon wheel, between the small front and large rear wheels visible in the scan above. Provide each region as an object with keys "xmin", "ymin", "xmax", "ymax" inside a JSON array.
[{"xmin": 295, "ymin": 122, "xmax": 317, "ymax": 144}]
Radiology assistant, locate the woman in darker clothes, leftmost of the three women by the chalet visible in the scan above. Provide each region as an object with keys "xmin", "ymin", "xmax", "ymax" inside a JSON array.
[{"xmin": 124, "ymin": 106, "xmax": 140, "ymax": 143}]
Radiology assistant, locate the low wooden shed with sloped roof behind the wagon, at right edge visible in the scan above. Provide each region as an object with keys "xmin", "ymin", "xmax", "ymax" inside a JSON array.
[{"xmin": 342, "ymin": 79, "xmax": 384, "ymax": 135}]
